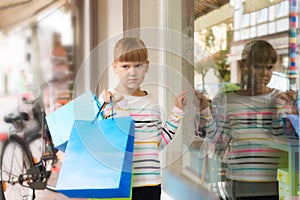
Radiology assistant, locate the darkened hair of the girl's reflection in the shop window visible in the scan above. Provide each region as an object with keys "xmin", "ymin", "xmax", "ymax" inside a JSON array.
[{"xmin": 242, "ymin": 40, "xmax": 277, "ymax": 64}]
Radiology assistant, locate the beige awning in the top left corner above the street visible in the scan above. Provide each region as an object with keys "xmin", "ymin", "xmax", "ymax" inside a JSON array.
[{"xmin": 0, "ymin": 0, "xmax": 67, "ymax": 34}]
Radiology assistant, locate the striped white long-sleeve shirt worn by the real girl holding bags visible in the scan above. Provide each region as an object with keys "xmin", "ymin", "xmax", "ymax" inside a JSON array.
[{"xmin": 100, "ymin": 90, "xmax": 183, "ymax": 187}]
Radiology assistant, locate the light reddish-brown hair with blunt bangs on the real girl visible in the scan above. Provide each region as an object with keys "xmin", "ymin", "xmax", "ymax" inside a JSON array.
[{"xmin": 114, "ymin": 37, "xmax": 148, "ymax": 62}]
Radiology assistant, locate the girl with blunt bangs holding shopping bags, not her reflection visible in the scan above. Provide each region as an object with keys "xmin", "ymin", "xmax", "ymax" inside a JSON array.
[{"xmin": 99, "ymin": 37, "xmax": 187, "ymax": 200}]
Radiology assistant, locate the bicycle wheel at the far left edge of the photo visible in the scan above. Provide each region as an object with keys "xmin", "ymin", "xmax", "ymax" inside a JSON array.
[{"xmin": 0, "ymin": 135, "xmax": 35, "ymax": 200}]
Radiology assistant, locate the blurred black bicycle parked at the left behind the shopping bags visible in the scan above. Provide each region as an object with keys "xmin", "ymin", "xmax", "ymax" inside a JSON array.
[{"xmin": 0, "ymin": 83, "xmax": 57, "ymax": 200}]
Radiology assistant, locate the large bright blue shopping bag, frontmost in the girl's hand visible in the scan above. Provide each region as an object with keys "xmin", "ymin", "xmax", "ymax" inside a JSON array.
[{"xmin": 56, "ymin": 116, "xmax": 134, "ymax": 198}]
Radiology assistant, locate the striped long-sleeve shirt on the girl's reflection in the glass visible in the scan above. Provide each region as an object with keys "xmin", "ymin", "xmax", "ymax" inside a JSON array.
[{"xmin": 202, "ymin": 90, "xmax": 289, "ymax": 182}]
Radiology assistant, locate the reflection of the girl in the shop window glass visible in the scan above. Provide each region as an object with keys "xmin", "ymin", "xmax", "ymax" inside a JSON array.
[{"xmin": 196, "ymin": 40, "xmax": 293, "ymax": 199}]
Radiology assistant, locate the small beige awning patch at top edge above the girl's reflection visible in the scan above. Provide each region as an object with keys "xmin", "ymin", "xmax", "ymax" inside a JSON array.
[{"xmin": 244, "ymin": 0, "xmax": 283, "ymax": 13}]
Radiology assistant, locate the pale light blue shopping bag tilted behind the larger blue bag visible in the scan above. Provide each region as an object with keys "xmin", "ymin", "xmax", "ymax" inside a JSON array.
[{"xmin": 46, "ymin": 91, "xmax": 99, "ymax": 152}]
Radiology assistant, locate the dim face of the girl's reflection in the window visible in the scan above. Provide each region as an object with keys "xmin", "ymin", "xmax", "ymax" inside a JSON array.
[{"xmin": 248, "ymin": 63, "xmax": 274, "ymax": 88}]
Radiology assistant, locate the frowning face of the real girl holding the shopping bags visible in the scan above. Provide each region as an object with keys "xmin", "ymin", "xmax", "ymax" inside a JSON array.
[{"xmin": 112, "ymin": 61, "xmax": 149, "ymax": 92}]
